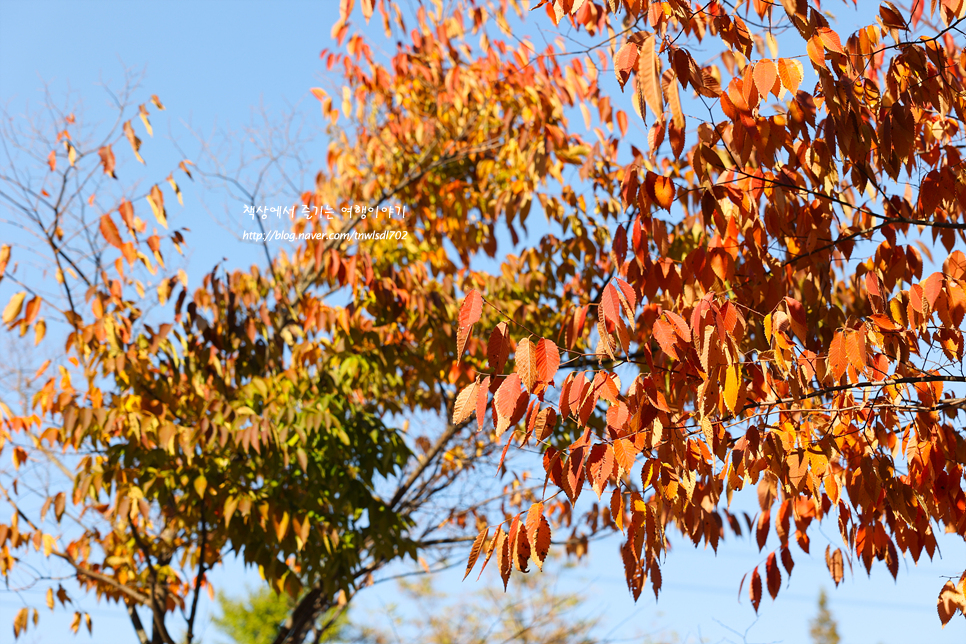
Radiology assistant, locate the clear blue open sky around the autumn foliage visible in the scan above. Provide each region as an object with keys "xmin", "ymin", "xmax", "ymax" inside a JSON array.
[{"xmin": 0, "ymin": 0, "xmax": 966, "ymax": 644}]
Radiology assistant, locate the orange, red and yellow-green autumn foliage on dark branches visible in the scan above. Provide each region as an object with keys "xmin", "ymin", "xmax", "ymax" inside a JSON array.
[{"xmin": 0, "ymin": 0, "xmax": 966, "ymax": 644}]
